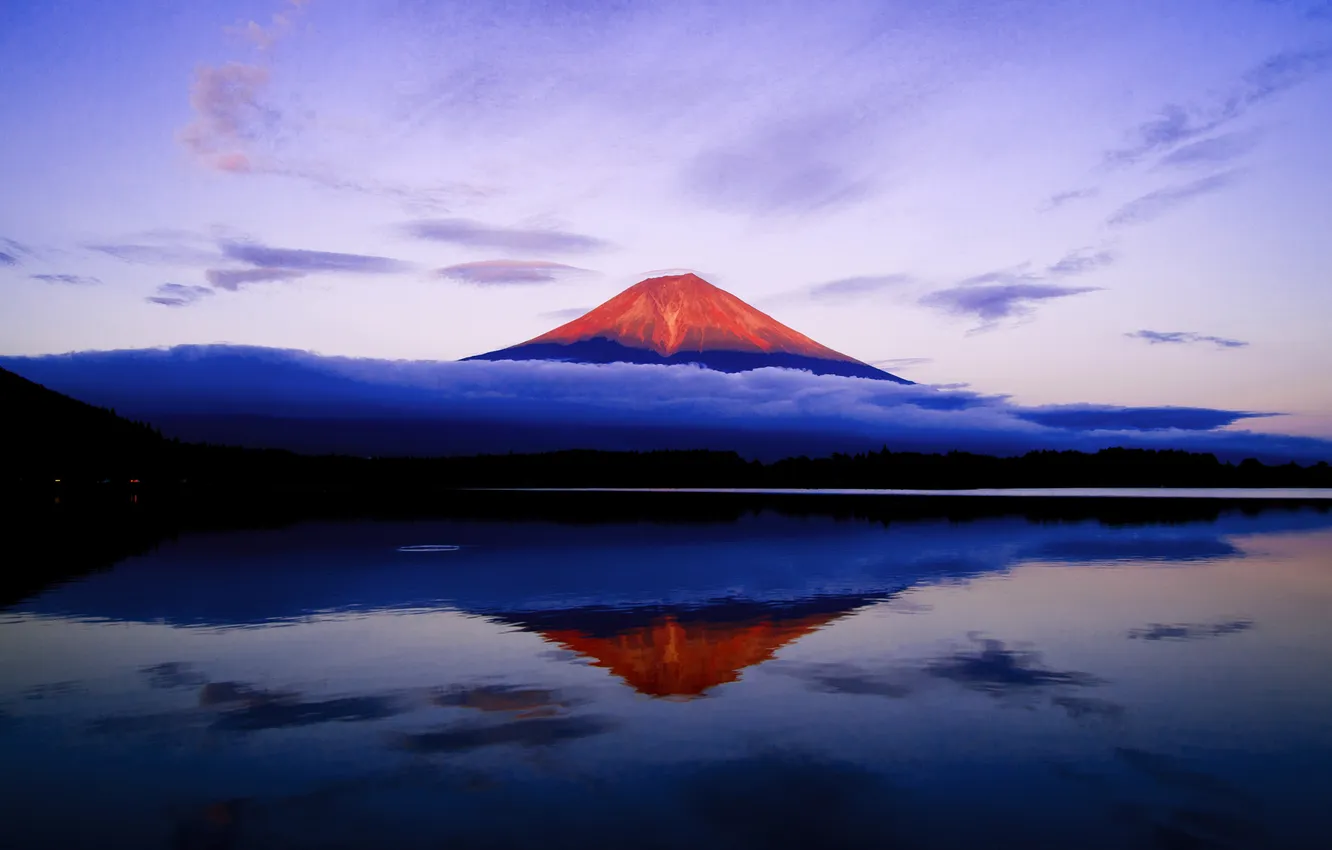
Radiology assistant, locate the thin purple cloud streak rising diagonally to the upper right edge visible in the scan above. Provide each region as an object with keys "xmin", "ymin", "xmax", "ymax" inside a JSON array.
[{"xmin": 1106, "ymin": 47, "xmax": 1332, "ymax": 165}]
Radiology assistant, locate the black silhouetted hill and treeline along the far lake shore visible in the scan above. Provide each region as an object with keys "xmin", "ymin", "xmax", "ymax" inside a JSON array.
[{"xmin": 0, "ymin": 369, "xmax": 1332, "ymax": 498}]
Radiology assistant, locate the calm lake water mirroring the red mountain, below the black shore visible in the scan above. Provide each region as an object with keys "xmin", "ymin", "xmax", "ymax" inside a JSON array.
[{"xmin": 0, "ymin": 509, "xmax": 1332, "ymax": 850}]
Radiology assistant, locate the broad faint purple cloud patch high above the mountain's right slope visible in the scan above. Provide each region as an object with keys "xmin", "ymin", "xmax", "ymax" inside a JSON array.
[{"xmin": 682, "ymin": 112, "xmax": 872, "ymax": 214}]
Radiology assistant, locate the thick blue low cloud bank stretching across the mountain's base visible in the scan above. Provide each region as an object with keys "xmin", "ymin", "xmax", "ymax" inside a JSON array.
[{"xmin": 0, "ymin": 346, "xmax": 1332, "ymax": 460}]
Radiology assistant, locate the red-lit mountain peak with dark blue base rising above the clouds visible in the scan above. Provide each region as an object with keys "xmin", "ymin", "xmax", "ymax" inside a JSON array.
[{"xmin": 466, "ymin": 274, "xmax": 911, "ymax": 384}]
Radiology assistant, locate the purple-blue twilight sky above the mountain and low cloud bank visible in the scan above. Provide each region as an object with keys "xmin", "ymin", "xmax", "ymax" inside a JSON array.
[{"xmin": 0, "ymin": 0, "xmax": 1332, "ymax": 437}]
